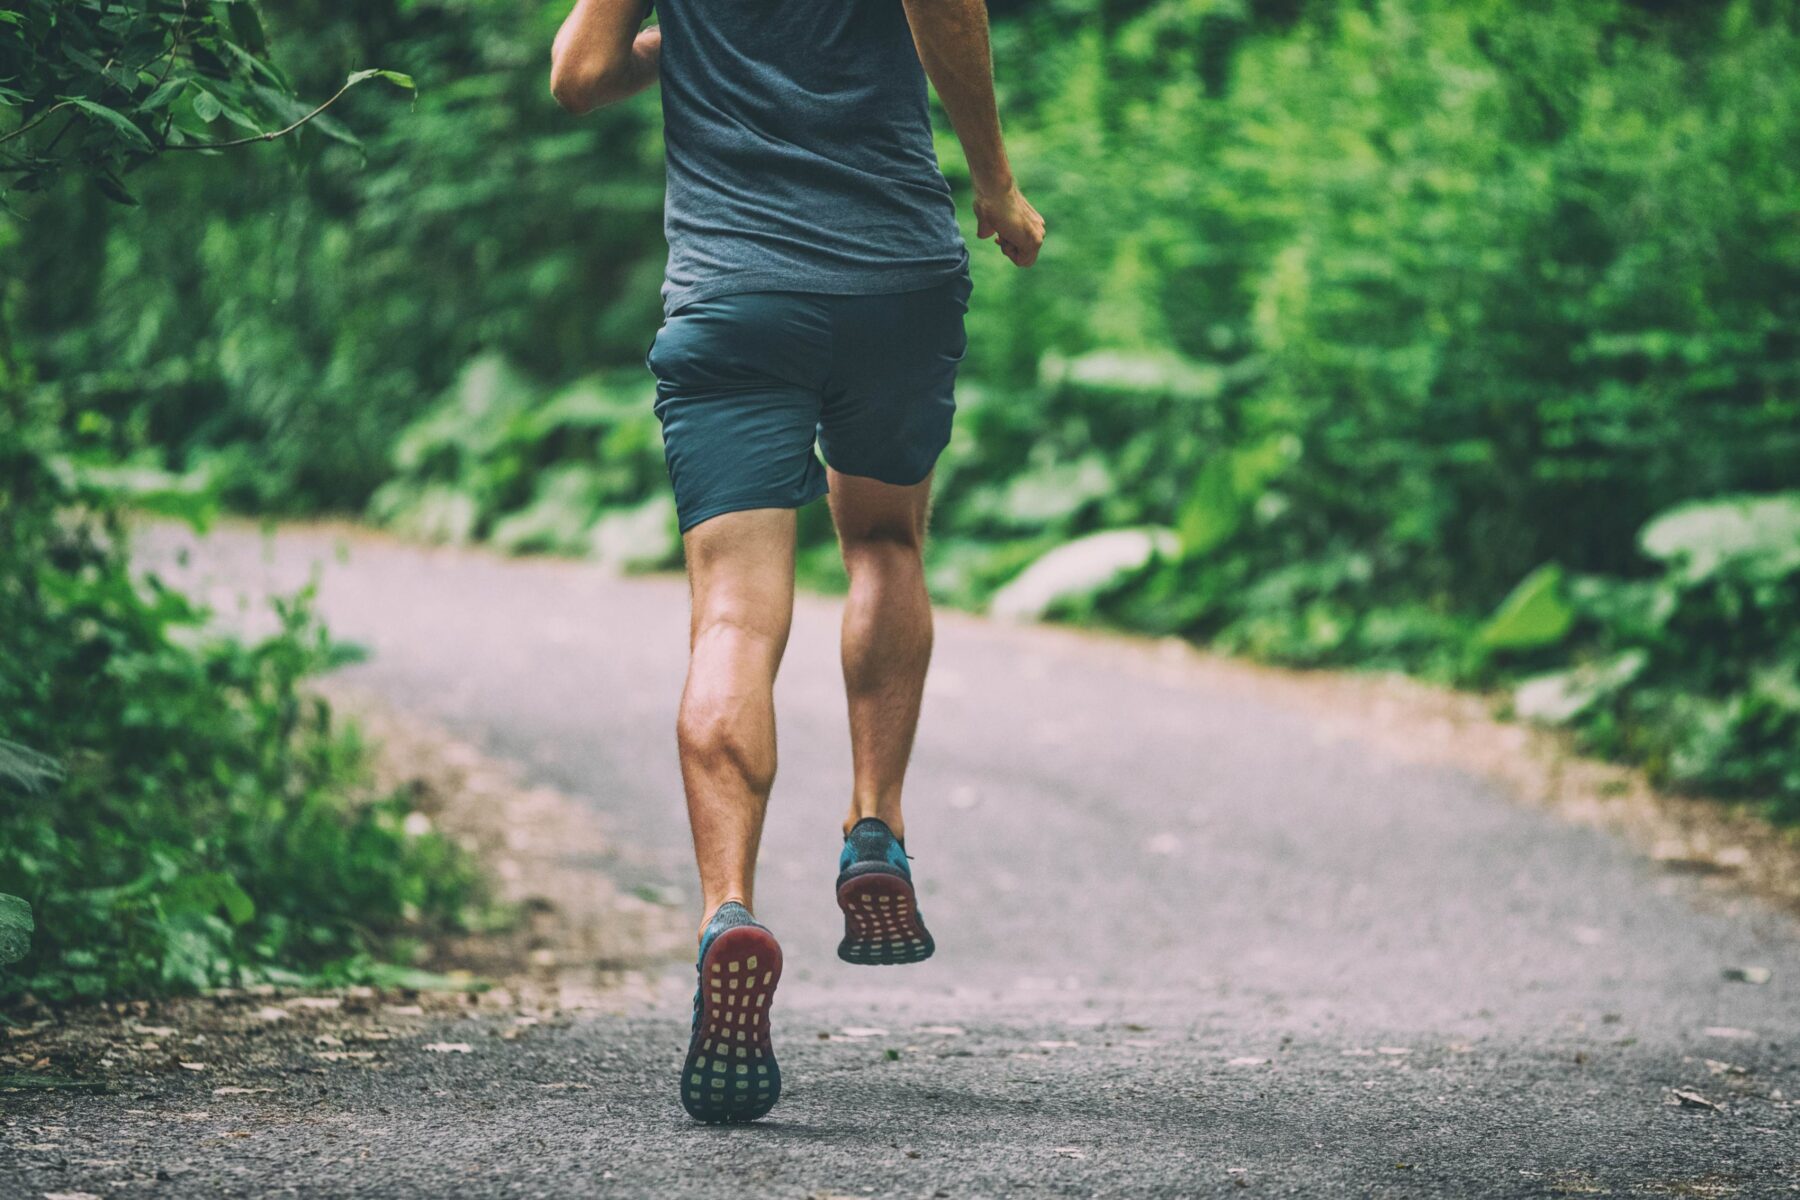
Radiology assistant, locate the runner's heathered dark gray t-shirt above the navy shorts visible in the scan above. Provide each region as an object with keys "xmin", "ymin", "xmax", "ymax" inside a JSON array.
[{"xmin": 655, "ymin": 0, "xmax": 968, "ymax": 313}]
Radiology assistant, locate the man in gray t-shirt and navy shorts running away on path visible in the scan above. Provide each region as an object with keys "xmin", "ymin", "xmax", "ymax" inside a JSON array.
[{"xmin": 551, "ymin": 0, "xmax": 1044, "ymax": 1121}]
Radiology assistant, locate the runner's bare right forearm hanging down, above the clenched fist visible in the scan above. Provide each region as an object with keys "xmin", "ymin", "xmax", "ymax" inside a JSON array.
[{"xmin": 904, "ymin": 0, "xmax": 1013, "ymax": 193}]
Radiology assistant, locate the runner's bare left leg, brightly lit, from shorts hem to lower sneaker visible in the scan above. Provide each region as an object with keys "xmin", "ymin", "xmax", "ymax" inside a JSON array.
[{"xmin": 677, "ymin": 509, "xmax": 794, "ymax": 930}]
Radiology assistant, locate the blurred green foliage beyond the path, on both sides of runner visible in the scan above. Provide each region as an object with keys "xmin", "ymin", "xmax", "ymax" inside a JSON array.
[{"xmin": 14, "ymin": 0, "xmax": 1800, "ymax": 827}]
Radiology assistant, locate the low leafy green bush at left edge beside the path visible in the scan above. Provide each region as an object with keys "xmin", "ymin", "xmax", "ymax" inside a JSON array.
[{"xmin": 0, "ymin": 390, "xmax": 479, "ymax": 997}]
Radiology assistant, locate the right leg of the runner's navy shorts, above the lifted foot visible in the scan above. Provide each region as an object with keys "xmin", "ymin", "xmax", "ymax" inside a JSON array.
[{"xmin": 819, "ymin": 275, "xmax": 968, "ymax": 488}]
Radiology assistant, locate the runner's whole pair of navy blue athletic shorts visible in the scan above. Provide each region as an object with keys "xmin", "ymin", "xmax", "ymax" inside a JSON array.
[{"xmin": 644, "ymin": 273, "xmax": 972, "ymax": 533}]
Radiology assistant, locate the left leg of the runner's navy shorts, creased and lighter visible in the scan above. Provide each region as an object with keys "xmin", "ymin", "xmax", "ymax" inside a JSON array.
[{"xmin": 644, "ymin": 291, "xmax": 830, "ymax": 534}]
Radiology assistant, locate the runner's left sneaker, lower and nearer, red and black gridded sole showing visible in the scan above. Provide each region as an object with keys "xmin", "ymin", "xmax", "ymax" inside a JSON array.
[{"xmin": 680, "ymin": 900, "xmax": 781, "ymax": 1124}]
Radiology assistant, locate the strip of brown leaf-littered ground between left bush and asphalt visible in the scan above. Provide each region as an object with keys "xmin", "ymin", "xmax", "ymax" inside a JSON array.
[{"xmin": 0, "ymin": 678, "xmax": 691, "ymax": 1096}]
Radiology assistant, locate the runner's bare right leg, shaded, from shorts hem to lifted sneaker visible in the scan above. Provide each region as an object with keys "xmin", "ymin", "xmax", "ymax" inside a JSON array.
[{"xmin": 828, "ymin": 471, "xmax": 931, "ymax": 838}]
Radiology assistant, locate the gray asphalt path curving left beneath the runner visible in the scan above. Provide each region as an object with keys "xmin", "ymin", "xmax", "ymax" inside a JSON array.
[{"xmin": 0, "ymin": 525, "xmax": 1800, "ymax": 1198}]
